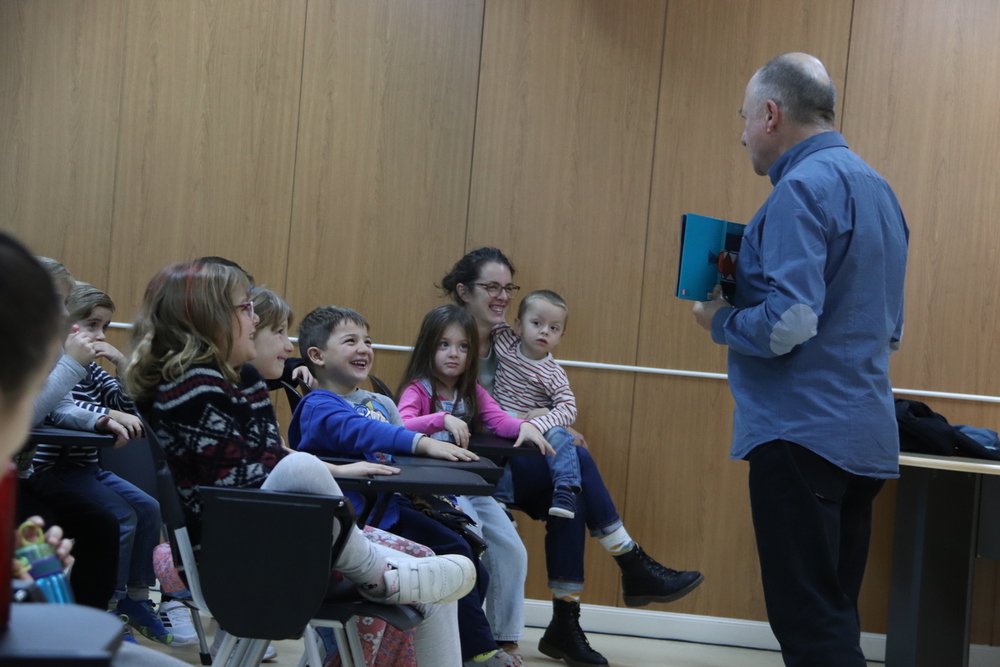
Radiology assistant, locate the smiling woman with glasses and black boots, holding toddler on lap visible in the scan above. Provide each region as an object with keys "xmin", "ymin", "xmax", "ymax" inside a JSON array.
[{"xmin": 441, "ymin": 248, "xmax": 704, "ymax": 665}]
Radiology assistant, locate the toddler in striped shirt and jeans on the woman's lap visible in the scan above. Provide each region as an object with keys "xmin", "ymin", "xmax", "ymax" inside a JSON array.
[{"xmin": 493, "ymin": 290, "xmax": 580, "ymax": 519}]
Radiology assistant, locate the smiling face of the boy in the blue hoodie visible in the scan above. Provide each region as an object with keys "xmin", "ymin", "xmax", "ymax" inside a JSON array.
[{"xmin": 307, "ymin": 320, "xmax": 375, "ymax": 395}]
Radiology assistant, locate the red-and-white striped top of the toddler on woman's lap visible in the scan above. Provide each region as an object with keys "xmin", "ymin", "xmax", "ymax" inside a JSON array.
[{"xmin": 493, "ymin": 325, "xmax": 576, "ymax": 433}]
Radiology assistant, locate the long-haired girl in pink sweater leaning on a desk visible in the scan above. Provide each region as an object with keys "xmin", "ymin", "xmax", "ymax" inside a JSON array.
[{"xmin": 399, "ymin": 304, "xmax": 553, "ymax": 454}]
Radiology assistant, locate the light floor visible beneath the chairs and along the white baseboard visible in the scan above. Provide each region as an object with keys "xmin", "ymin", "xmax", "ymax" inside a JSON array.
[{"xmin": 140, "ymin": 627, "xmax": 881, "ymax": 667}]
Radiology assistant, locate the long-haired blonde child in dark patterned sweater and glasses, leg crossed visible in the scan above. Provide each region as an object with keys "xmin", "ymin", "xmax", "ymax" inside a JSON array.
[{"xmin": 127, "ymin": 261, "xmax": 475, "ymax": 666}]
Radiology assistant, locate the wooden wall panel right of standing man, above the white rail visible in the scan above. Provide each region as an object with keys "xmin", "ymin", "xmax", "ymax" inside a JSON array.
[{"xmin": 844, "ymin": 0, "xmax": 1000, "ymax": 396}]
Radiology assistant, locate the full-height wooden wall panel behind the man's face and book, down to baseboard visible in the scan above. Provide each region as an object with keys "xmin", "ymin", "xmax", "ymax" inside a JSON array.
[{"xmin": 627, "ymin": 0, "xmax": 851, "ymax": 620}]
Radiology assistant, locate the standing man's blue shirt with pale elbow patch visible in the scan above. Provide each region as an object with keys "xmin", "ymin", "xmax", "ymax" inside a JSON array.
[{"xmin": 712, "ymin": 132, "xmax": 909, "ymax": 478}]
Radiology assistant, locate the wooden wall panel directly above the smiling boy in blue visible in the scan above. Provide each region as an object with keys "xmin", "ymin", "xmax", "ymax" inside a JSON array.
[{"xmin": 288, "ymin": 0, "xmax": 483, "ymax": 345}]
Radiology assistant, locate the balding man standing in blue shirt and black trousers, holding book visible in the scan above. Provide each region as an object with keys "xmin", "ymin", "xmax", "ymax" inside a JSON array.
[{"xmin": 694, "ymin": 53, "xmax": 909, "ymax": 667}]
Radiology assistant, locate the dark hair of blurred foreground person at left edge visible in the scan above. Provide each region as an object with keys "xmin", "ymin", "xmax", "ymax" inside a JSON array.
[{"xmin": 0, "ymin": 232, "xmax": 65, "ymax": 407}]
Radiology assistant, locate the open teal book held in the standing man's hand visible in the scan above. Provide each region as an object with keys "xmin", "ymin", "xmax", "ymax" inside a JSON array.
[{"xmin": 677, "ymin": 213, "xmax": 746, "ymax": 301}]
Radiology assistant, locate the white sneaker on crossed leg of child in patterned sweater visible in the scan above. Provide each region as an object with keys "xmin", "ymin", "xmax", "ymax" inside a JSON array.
[{"xmin": 368, "ymin": 554, "xmax": 476, "ymax": 604}]
